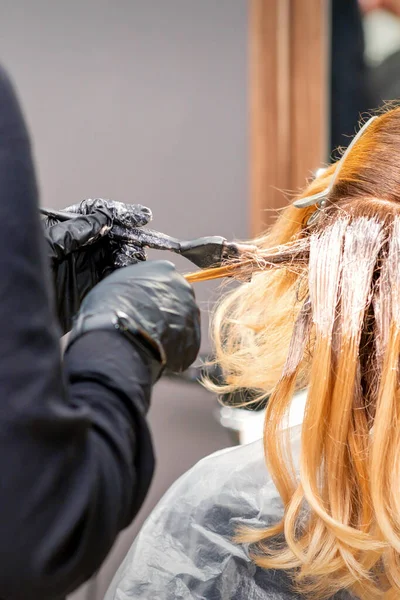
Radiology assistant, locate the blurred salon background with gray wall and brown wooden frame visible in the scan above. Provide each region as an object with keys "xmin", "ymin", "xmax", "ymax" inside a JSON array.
[{"xmin": 0, "ymin": 0, "xmax": 400, "ymax": 600}]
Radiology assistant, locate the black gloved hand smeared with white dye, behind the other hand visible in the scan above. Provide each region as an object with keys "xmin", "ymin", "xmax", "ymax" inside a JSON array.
[{"xmin": 43, "ymin": 199, "xmax": 151, "ymax": 333}]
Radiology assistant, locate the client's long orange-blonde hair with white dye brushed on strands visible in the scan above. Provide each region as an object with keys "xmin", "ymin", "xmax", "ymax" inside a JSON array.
[{"xmin": 190, "ymin": 109, "xmax": 400, "ymax": 600}]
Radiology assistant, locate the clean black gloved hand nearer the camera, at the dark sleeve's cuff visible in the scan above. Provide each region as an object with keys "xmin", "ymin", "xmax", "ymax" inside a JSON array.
[{"xmin": 69, "ymin": 261, "xmax": 200, "ymax": 381}]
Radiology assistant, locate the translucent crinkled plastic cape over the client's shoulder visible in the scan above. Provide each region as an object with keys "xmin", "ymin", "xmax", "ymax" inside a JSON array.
[{"xmin": 105, "ymin": 427, "xmax": 351, "ymax": 600}]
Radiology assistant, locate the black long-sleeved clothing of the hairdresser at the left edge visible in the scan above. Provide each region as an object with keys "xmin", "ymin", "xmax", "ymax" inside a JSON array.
[{"xmin": 0, "ymin": 65, "xmax": 153, "ymax": 600}]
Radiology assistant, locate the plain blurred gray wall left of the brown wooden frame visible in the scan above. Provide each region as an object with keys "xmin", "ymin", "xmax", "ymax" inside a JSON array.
[{"xmin": 0, "ymin": 0, "xmax": 248, "ymax": 598}]
